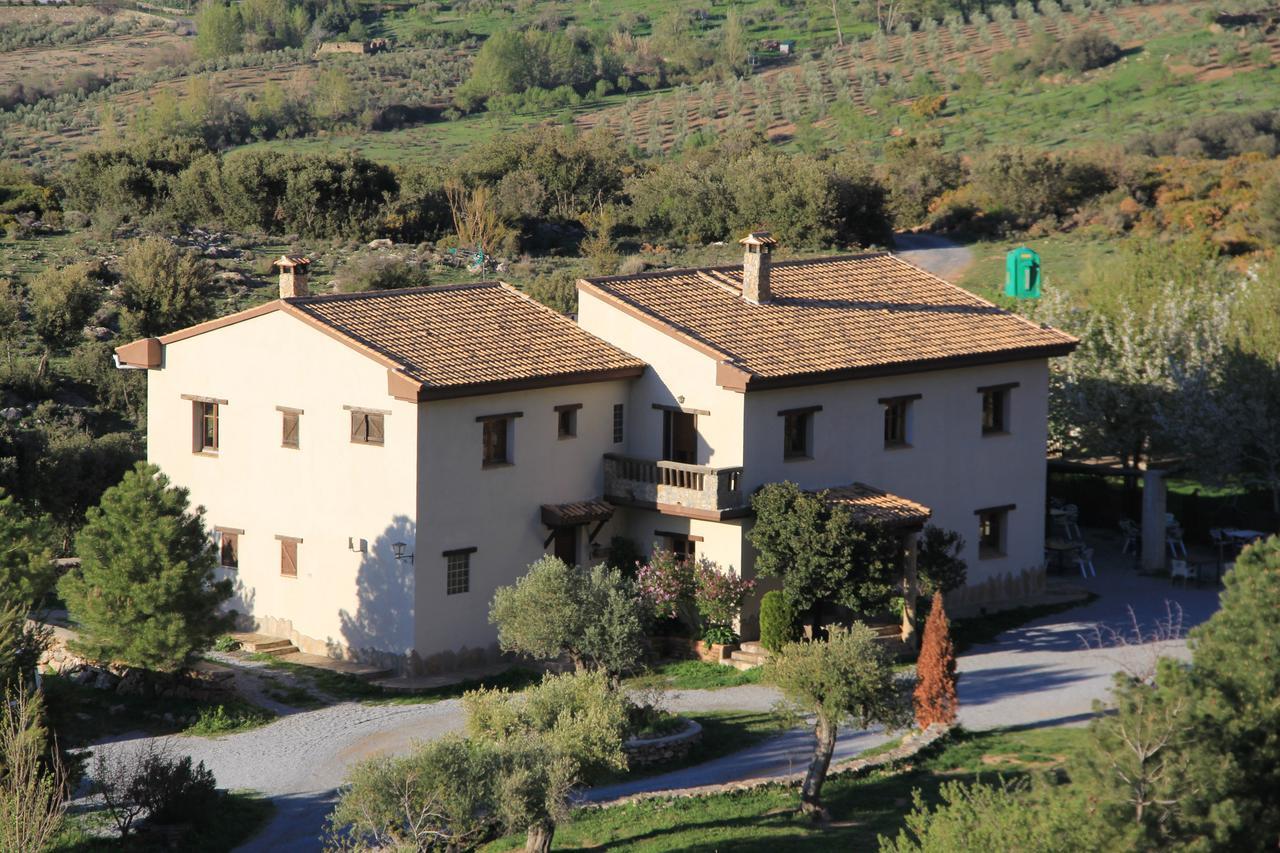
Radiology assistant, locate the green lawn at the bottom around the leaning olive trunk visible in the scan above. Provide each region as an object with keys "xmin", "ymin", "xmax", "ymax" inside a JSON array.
[{"xmin": 486, "ymin": 729, "xmax": 1087, "ymax": 853}]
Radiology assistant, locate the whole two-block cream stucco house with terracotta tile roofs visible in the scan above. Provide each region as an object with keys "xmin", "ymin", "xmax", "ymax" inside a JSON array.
[{"xmin": 118, "ymin": 234, "xmax": 1075, "ymax": 669}]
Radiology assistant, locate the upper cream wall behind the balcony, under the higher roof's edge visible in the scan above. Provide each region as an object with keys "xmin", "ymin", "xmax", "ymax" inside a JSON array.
[{"xmin": 577, "ymin": 291, "xmax": 744, "ymax": 467}]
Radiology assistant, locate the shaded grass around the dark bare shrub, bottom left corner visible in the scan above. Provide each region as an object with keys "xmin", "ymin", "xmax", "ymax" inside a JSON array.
[{"xmin": 51, "ymin": 792, "xmax": 275, "ymax": 853}]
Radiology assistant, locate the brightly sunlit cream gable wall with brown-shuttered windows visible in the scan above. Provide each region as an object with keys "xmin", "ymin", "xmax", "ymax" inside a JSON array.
[{"xmin": 147, "ymin": 311, "xmax": 417, "ymax": 653}]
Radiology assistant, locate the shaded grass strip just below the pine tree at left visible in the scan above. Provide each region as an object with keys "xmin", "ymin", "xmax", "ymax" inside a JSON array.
[{"xmin": 44, "ymin": 675, "xmax": 275, "ymax": 747}]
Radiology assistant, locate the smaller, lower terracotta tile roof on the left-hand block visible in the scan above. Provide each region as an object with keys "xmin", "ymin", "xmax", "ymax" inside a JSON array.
[{"xmin": 287, "ymin": 282, "xmax": 644, "ymax": 396}]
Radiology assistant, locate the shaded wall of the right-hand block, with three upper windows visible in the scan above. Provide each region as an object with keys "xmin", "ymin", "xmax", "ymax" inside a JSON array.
[{"xmin": 744, "ymin": 360, "xmax": 1048, "ymax": 584}]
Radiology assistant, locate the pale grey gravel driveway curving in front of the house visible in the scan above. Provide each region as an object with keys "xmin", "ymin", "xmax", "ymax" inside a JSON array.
[{"xmin": 85, "ymin": 545, "xmax": 1217, "ymax": 853}]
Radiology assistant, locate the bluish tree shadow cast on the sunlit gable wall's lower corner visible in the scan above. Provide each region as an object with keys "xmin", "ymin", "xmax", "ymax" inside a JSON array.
[{"xmin": 338, "ymin": 515, "xmax": 417, "ymax": 662}]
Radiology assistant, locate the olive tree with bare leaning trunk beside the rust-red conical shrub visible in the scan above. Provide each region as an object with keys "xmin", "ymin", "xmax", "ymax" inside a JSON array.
[{"xmin": 763, "ymin": 622, "xmax": 911, "ymax": 818}]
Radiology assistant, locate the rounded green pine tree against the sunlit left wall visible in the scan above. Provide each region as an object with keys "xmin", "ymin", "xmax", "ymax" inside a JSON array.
[{"xmin": 59, "ymin": 462, "xmax": 232, "ymax": 671}]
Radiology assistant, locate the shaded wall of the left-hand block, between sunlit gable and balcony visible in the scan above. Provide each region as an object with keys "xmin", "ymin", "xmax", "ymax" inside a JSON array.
[{"xmin": 416, "ymin": 380, "xmax": 628, "ymax": 657}]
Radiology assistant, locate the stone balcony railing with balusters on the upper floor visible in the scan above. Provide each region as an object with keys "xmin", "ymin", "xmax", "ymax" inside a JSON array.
[{"xmin": 604, "ymin": 453, "xmax": 745, "ymax": 511}]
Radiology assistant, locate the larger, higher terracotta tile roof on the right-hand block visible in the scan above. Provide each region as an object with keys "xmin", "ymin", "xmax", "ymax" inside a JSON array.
[{"xmin": 579, "ymin": 252, "xmax": 1076, "ymax": 387}]
